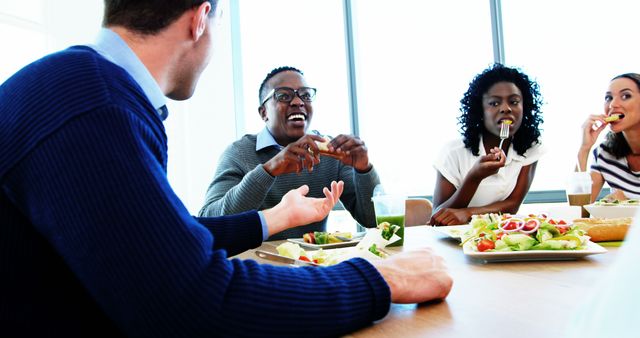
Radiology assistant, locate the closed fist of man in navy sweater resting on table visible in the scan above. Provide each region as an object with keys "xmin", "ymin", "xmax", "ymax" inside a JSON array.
[{"xmin": 373, "ymin": 248, "xmax": 453, "ymax": 303}]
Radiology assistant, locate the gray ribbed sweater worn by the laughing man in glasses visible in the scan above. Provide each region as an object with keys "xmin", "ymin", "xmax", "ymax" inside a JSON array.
[{"xmin": 200, "ymin": 135, "xmax": 380, "ymax": 240}]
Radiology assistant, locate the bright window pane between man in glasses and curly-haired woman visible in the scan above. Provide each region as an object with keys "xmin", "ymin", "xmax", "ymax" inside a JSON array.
[{"xmin": 353, "ymin": 0, "xmax": 493, "ymax": 195}]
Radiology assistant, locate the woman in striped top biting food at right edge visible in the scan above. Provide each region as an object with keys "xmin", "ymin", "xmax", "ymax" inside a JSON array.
[{"xmin": 578, "ymin": 73, "xmax": 640, "ymax": 202}]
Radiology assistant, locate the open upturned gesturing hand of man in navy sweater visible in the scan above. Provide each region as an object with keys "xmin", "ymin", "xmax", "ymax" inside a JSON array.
[{"xmin": 263, "ymin": 181, "xmax": 344, "ymax": 236}]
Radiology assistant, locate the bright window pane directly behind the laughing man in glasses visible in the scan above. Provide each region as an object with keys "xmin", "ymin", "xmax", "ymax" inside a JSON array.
[{"xmin": 239, "ymin": 0, "xmax": 350, "ymax": 136}]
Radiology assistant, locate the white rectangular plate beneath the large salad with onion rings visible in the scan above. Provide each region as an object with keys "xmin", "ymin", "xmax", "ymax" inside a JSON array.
[{"xmin": 463, "ymin": 241, "xmax": 607, "ymax": 262}]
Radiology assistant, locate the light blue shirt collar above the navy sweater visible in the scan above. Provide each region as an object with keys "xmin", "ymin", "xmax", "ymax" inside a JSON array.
[{"xmin": 89, "ymin": 28, "xmax": 168, "ymax": 120}]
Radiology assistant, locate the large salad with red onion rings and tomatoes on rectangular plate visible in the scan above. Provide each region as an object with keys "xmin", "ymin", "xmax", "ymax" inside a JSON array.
[{"xmin": 461, "ymin": 214, "xmax": 589, "ymax": 252}]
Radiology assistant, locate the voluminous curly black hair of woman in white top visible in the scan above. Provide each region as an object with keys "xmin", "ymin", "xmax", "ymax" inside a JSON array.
[{"xmin": 458, "ymin": 63, "xmax": 544, "ymax": 156}]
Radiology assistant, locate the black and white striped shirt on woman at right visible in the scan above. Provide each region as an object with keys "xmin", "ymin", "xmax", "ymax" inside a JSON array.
[{"xmin": 591, "ymin": 145, "xmax": 640, "ymax": 198}]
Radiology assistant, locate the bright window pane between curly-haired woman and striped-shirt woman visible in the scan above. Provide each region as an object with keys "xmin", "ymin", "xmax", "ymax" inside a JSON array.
[{"xmin": 502, "ymin": 0, "xmax": 640, "ymax": 190}]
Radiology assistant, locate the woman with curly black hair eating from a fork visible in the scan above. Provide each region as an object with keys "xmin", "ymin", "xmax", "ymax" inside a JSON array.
[{"xmin": 429, "ymin": 64, "xmax": 543, "ymax": 225}]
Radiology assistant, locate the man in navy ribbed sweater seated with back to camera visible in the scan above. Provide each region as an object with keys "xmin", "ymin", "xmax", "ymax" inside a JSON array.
[{"xmin": 0, "ymin": 0, "xmax": 452, "ymax": 337}]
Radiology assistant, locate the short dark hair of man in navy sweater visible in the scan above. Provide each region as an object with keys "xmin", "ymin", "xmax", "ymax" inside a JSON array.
[{"xmin": 102, "ymin": 0, "xmax": 218, "ymax": 35}]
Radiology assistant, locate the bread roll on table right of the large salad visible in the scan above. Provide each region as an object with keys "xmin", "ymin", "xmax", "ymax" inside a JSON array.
[{"xmin": 573, "ymin": 217, "xmax": 633, "ymax": 242}]
